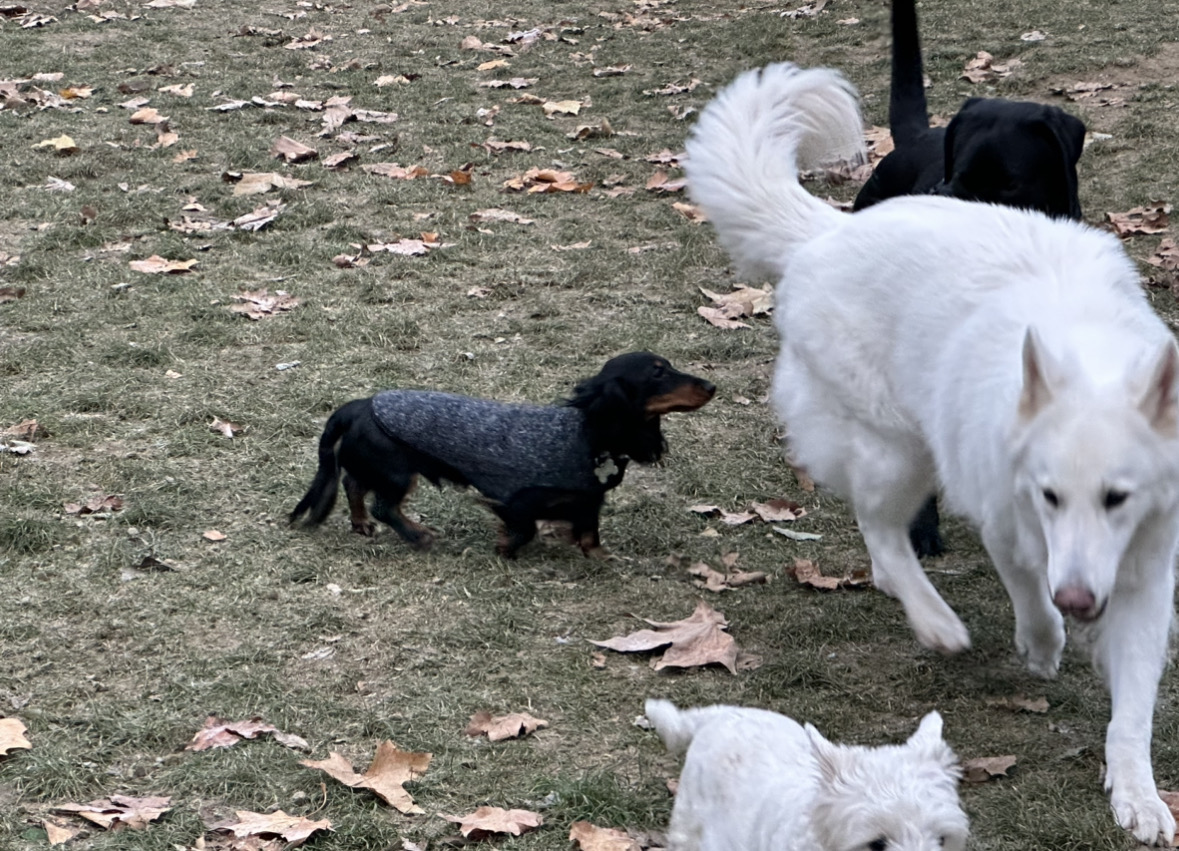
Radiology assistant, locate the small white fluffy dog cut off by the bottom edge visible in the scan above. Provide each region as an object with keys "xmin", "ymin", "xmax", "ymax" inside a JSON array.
[{"xmin": 646, "ymin": 700, "xmax": 969, "ymax": 851}]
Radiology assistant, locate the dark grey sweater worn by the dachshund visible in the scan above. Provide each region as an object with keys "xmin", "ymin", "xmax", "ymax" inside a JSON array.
[{"xmin": 373, "ymin": 390, "xmax": 625, "ymax": 502}]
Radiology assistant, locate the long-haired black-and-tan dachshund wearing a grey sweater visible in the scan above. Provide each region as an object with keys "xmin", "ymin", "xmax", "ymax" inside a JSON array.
[{"xmin": 290, "ymin": 351, "xmax": 716, "ymax": 558}]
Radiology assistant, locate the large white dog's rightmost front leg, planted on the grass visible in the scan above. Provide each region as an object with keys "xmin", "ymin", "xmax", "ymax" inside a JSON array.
[{"xmin": 1094, "ymin": 570, "xmax": 1175, "ymax": 845}]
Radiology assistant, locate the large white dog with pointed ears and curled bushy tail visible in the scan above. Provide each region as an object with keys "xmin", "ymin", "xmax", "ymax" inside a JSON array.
[{"xmin": 687, "ymin": 64, "xmax": 1179, "ymax": 843}]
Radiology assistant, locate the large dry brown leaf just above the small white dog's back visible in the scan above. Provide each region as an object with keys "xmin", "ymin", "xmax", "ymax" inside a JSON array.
[{"xmin": 590, "ymin": 600, "xmax": 737, "ymax": 673}]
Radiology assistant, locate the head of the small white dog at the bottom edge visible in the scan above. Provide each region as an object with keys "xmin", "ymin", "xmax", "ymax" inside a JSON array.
[{"xmin": 806, "ymin": 712, "xmax": 969, "ymax": 851}]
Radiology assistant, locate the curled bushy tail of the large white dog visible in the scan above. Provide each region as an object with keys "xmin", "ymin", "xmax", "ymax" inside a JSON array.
[{"xmin": 684, "ymin": 62, "xmax": 864, "ymax": 279}]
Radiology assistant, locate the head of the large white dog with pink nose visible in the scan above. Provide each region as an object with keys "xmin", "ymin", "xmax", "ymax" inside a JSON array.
[{"xmin": 1015, "ymin": 329, "xmax": 1179, "ymax": 621}]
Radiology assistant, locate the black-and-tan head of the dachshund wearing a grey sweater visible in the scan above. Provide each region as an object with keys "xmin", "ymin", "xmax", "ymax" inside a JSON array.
[{"xmin": 566, "ymin": 351, "xmax": 717, "ymax": 463}]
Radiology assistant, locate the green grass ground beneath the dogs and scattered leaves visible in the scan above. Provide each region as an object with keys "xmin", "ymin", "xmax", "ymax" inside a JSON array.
[{"xmin": 0, "ymin": 0, "xmax": 1179, "ymax": 851}]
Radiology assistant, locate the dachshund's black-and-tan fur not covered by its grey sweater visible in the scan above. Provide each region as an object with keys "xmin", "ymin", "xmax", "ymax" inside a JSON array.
[{"xmin": 290, "ymin": 352, "xmax": 716, "ymax": 558}]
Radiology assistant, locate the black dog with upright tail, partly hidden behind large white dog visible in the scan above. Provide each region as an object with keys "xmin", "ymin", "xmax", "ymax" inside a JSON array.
[{"xmin": 852, "ymin": 0, "xmax": 1085, "ymax": 555}]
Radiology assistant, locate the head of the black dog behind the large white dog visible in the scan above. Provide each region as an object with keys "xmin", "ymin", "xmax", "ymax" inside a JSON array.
[{"xmin": 938, "ymin": 98, "xmax": 1085, "ymax": 219}]
